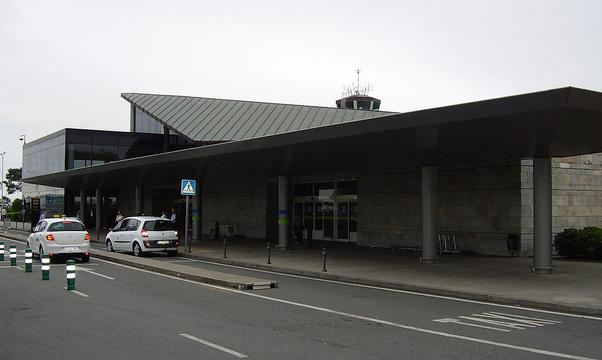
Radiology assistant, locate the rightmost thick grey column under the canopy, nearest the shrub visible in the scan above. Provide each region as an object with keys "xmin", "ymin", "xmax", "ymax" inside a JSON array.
[{"xmin": 533, "ymin": 158, "xmax": 552, "ymax": 274}]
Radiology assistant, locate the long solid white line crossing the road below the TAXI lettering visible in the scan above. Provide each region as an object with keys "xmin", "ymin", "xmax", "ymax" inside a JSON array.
[{"xmin": 98, "ymin": 259, "xmax": 600, "ymax": 360}]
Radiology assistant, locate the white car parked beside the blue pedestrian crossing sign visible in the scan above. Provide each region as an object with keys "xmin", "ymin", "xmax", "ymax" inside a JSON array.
[{"xmin": 106, "ymin": 216, "xmax": 180, "ymax": 256}]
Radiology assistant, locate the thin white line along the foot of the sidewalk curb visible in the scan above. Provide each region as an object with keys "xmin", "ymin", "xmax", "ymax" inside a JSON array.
[{"xmin": 178, "ymin": 257, "xmax": 602, "ymax": 321}]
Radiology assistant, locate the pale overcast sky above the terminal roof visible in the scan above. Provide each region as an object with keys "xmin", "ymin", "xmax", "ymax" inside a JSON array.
[{"xmin": 0, "ymin": 0, "xmax": 602, "ymax": 186}]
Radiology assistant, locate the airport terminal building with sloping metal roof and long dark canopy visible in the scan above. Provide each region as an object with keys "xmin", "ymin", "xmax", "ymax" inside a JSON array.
[{"xmin": 23, "ymin": 87, "xmax": 602, "ymax": 273}]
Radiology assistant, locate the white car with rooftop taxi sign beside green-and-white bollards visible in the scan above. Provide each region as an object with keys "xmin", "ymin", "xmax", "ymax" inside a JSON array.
[{"xmin": 27, "ymin": 218, "xmax": 90, "ymax": 262}]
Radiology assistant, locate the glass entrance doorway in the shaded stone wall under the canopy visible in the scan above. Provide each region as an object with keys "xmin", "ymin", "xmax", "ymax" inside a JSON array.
[{"xmin": 293, "ymin": 180, "xmax": 358, "ymax": 242}]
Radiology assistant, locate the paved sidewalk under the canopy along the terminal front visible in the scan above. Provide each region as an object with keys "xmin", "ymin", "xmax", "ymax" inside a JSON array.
[{"xmin": 0, "ymin": 231, "xmax": 602, "ymax": 316}]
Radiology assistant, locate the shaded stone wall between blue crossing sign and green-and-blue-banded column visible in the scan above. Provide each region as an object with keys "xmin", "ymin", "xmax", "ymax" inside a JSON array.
[{"xmin": 201, "ymin": 181, "xmax": 267, "ymax": 238}]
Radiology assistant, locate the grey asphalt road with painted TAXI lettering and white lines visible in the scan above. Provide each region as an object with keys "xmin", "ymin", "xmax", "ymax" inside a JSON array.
[{"xmin": 0, "ymin": 239, "xmax": 602, "ymax": 360}]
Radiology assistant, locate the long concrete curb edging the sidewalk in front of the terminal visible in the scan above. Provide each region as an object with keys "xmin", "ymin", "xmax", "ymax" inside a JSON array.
[{"xmin": 178, "ymin": 253, "xmax": 602, "ymax": 316}]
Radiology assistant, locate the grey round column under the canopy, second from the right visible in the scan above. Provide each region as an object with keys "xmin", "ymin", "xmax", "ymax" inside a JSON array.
[{"xmin": 420, "ymin": 166, "xmax": 438, "ymax": 264}]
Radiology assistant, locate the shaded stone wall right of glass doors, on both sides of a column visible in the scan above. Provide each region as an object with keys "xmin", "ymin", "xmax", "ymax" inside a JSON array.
[{"xmin": 358, "ymin": 163, "xmax": 521, "ymax": 255}]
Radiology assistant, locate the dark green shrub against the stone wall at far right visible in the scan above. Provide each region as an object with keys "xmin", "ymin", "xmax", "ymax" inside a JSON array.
[{"xmin": 554, "ymin": 226, "xmax": 602, "ymax": 260}]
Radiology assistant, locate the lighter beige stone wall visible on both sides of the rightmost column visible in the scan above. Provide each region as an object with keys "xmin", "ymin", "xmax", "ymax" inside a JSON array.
[{"xmin": 521, "ymin": 153, "xmax": 602, "ymax": 255}]
